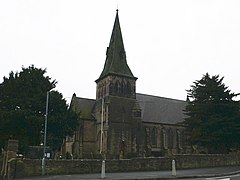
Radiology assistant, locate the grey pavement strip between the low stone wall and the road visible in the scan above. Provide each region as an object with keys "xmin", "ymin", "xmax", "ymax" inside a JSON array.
[{"xmin": 17, "ymin": 166, "xmax": 240, "ymax": 180}]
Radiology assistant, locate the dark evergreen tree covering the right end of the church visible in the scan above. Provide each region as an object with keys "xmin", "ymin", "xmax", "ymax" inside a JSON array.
[{"xmin": 185, "ymin": 73, "xmax": 240, "ymax": 153}]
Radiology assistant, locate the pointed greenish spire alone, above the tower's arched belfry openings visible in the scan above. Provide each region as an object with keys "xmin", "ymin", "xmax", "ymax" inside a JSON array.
[{"xmin": 96, "ymin": 9, "xmax": 135, "ymax": 82}]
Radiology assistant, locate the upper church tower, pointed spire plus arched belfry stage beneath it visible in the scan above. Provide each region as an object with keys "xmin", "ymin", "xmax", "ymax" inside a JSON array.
[{"xmin": 96, "ymin": 10, "xmax": 137, "ymax": 100}]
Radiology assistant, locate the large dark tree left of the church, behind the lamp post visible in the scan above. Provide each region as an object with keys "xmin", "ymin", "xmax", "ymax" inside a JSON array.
[{"xmin": 0, "ymin": 65, "xmax": 77, "ymax": 152}]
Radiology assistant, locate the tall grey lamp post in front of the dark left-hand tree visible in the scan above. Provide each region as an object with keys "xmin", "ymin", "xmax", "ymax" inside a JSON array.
[{"xmin": 42, "ymin": 91, "xmax": 49, "ymax": 176}]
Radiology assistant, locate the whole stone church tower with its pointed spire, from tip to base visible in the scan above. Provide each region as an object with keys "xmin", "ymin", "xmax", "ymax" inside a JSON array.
[{"xmin": 95, "ymin": 10, "xmax": 141, "ymax": 158}]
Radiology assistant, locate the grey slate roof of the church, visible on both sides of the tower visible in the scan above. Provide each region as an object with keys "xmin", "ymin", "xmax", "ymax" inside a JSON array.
[{"xmin": 73, "ymin": 93, "xmax": 187, "ymax": 124}]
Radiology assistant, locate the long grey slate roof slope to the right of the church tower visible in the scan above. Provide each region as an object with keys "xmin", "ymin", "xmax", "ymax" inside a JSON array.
[{"xmin": 136, "ymin": 93, "xmax": 186, "ymax": 124}]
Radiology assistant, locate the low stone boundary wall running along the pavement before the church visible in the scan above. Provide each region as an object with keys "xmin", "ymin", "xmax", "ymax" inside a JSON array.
[{"xmin": 6, "ymin": 154, "xmax": 240, "ymax": 178}]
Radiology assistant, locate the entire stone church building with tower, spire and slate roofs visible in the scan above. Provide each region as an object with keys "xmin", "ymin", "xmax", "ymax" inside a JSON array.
[{"xmin": 63, "ymin": 11, "xmax": 186, "ymax": 159}]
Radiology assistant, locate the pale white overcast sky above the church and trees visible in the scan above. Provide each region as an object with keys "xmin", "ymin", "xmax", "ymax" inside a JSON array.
[{"xmin": 0, "ymin": 0, "xmax": 240, "ymax": 101}]
